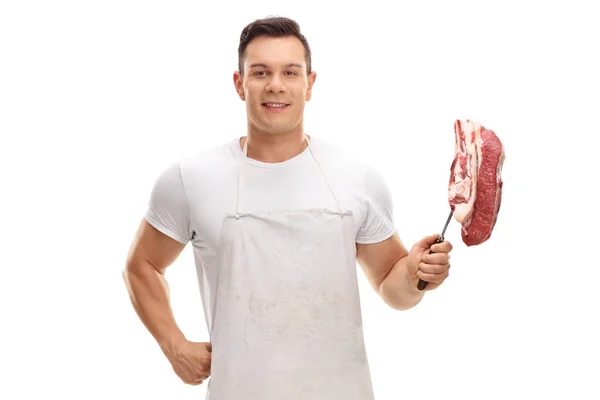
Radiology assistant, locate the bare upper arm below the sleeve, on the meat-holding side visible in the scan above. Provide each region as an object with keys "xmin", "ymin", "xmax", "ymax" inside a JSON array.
[{"xmin": 356, "ymin": 232, "xmax": 408, "ymax": 291}]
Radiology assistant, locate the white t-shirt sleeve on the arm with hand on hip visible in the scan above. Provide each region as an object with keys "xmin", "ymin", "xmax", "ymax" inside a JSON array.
[{"xmin": 145, "ymin": 163, "xmax": 191, "ymax": 244}]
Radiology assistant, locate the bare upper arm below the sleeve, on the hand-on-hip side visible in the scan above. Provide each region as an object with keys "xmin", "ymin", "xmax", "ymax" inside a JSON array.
[{"xmin": 127, "ymin": 218, "xmax": 185, "ymax": 274}]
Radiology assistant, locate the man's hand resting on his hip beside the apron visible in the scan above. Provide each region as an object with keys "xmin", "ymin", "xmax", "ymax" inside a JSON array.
[{"xmin": 165, "ymin": 340, "xmax": 212, "ymax": 385}]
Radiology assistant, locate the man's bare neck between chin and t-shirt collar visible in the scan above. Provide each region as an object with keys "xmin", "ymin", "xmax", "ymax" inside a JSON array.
[{"xmin": 240, "ymin": 129, "xmax": 307, "ymax": 163}]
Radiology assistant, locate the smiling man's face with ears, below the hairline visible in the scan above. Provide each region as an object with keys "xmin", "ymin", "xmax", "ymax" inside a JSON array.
[{"xmin": 234, "ymin": 36, "xmax": 316, "ymax": 135}]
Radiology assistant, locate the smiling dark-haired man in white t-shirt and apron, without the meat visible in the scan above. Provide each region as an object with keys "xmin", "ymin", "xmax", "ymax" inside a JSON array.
[{"xmin": 124, "ymin": 18, "xmax": 452, "ymax": 400}]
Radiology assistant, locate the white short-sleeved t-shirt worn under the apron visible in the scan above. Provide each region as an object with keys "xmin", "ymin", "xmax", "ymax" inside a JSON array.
[{"xmin": 145, "ymin": 136, "xmax": 396, "ymax": 333}]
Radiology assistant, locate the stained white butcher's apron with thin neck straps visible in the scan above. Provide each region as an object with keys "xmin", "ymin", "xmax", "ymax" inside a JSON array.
[{"xmin": 206, "ymin": 138, "xmax": 373, "ymax": 400}]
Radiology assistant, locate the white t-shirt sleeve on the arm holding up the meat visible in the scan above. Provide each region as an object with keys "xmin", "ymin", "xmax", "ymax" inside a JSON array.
[{"xmin": 356, "ymin": 166, "xmax": 396, "ymax": 244}]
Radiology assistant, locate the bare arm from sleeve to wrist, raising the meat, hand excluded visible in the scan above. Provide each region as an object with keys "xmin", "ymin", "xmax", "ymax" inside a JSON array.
[{"xmin": 356, "ymin": 232, "xmax": 424, "ymax": 310}]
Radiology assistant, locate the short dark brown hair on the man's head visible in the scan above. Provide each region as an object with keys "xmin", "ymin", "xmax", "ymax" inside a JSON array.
[{"xmin": 238, "ymin": 17, "xmax": 311, "ymax": 75}]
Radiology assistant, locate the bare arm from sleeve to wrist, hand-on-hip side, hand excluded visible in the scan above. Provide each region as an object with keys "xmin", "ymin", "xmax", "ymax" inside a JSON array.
[{"xmin": 123, "ymin": 219, "xmax": 185, "ymax": 353}]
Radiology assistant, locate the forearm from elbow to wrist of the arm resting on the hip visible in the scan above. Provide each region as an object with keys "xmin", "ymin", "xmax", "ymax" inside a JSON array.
[{"xmin": 123, "ymin": 261, "xmax": 185, "ymax": 352}]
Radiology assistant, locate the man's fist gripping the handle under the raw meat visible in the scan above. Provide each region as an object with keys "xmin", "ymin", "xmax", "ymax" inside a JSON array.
[{"xmin": 406, "ymin": 234, "xmax": 452, "ymax": 291}]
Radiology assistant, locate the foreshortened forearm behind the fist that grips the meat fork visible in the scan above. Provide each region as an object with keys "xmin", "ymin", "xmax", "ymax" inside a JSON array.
[{"xmin": 379, "ymin": 256, "xmax": 424, "ymax": 310}]
